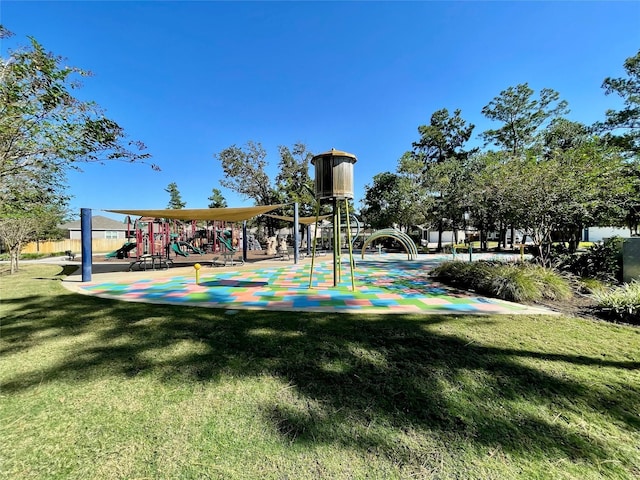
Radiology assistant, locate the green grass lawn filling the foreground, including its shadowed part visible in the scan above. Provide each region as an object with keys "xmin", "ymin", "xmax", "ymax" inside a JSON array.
[{"xmin": 0, "ymin": 265, "xmax": 640, "ymax": 479}]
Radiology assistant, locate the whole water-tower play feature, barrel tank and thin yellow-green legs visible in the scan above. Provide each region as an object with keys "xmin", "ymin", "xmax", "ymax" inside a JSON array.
[{"xmin": 309, "ymin": 148, "xmax": 357, "ymax": 290}]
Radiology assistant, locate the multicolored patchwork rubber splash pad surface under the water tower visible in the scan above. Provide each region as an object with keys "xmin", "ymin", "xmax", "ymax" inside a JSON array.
[{"xmin": 68, "ymin": 254, "xmax": 551, "ymax": 314}]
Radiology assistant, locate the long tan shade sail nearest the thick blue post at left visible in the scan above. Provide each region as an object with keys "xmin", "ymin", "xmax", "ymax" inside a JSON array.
[{"xmin": 105, "ymin": 204, "xmax": 284, "ymax": 222}]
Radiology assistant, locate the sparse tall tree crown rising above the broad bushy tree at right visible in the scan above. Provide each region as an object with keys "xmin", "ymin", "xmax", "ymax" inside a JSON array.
[{"xmin": 482, "ymin": 83, "xmax": 568, "ymax": 156}]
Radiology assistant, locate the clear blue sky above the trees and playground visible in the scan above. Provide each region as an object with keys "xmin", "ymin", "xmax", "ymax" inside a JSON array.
[{"xmin": 0, "ymin": 0, "xmax": 640, "ymax": 218}]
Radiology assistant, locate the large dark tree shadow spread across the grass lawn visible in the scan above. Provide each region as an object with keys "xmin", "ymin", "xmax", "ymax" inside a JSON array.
[{"xmin": 0, "ymin": 282, "xmax": 640, "ymax": 468}]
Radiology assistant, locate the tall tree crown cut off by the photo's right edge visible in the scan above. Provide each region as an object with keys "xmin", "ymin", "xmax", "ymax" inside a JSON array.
[{"xmin": 595, "ymin": 50, "xmax": 640, "ymax": 155}]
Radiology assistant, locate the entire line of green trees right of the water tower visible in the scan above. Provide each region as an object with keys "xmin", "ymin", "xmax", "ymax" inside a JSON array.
[{"xmin": 361, "ymin": 51, "xmax": 640, "ymax": 259}]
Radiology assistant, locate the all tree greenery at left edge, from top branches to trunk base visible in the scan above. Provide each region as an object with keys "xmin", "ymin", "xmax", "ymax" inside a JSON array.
[{"xmin": 0, "ymin": 26, "xmax": 157, "ymax": 269}]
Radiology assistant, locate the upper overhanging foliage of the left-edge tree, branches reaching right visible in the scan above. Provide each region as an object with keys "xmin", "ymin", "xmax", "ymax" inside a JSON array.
[{"xmin": 0, "ymin": 29, "xmax": 157, "ymax": 190}]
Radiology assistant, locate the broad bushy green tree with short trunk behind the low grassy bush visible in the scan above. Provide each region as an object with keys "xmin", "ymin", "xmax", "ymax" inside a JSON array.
[{"xmin": 465, "ymin": 137, "xmax": 633, "ymax": 264}]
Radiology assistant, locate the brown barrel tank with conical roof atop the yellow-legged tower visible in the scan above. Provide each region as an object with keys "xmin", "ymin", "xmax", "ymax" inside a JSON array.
[{"xmin": 311, "ymin": 148, "xmax": 357, "ymax": 200}]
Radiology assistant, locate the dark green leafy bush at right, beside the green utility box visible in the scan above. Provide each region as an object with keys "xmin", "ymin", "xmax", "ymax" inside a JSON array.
[{"xmin": 555, "ymin": 237, "xmax": 622, "ymax": 282}]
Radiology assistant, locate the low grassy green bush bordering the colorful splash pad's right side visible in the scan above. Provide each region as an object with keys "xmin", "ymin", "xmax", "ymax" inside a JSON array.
[{"xmin": 431, "ymin": 260, "xmax": 573, "ymax": 302}]
